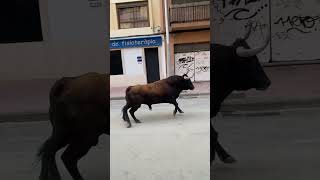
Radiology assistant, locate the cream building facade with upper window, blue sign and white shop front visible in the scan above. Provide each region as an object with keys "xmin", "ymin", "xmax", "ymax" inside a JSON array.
[{"xmin": 109, "ymin": 0, "xmax": 166, "ymax": 87}]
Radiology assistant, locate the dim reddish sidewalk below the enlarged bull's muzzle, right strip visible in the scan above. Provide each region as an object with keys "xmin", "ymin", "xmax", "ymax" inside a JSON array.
[{"xmin": 223, "ymin": 64, "xmax": 320, "ymax": 111}]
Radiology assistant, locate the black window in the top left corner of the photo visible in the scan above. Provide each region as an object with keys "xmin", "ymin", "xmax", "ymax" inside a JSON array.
[{"xmin": 0, "ymin": 0, "xmax": 43, "ymax": 43}]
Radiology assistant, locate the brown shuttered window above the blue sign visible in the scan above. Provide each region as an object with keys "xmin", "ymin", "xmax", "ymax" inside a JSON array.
[{"xmin": 117, "ymin": 1, "xmax": 150, "ymax": 29}]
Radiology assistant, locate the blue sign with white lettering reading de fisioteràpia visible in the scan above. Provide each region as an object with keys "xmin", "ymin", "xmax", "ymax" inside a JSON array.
[{"xmin": 110, "ymin": 36, "xmax": 162, "ymax": 49}]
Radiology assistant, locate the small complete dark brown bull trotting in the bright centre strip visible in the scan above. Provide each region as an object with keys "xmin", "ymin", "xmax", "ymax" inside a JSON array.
[{"xmin": 122, "ymin": 74, "xmax": 194, "ymax": 128}]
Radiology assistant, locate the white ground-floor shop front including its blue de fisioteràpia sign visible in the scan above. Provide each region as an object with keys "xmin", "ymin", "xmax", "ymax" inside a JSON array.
[{"xmin": 110, "ymin": 35, "xmax": 166, "ymax": 87}]
